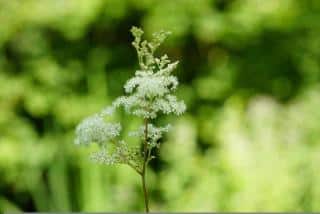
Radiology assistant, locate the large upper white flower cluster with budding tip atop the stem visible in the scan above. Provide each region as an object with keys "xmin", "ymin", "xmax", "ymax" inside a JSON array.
[{"xmin": 114, "ymin": 28, "xmax": 186, "ymax": 119}]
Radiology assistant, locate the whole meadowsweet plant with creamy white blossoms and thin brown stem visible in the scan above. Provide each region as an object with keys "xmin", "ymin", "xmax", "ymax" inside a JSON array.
[{"xmin": 75, "ymin": 27, "xmax": 186, "ymax": 212}]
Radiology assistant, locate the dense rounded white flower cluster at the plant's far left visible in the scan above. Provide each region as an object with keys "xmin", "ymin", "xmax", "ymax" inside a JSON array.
[{"xmin": 75, "ymin": 114, "xmax": 121, "ymax": 145}]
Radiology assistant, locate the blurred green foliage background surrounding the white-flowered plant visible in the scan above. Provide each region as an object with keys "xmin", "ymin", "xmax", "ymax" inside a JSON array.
[{"xmin": 0, "ymin": 0, "xmax": 320, "ymax": 212}]
